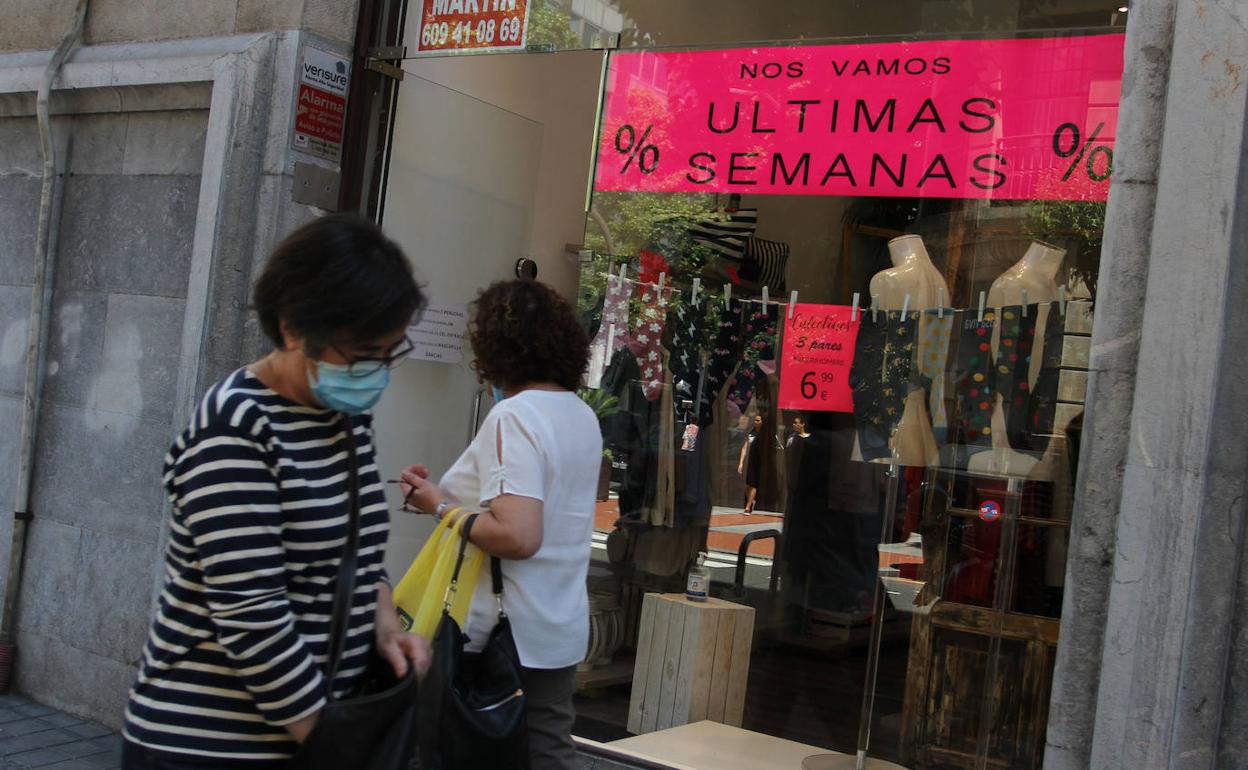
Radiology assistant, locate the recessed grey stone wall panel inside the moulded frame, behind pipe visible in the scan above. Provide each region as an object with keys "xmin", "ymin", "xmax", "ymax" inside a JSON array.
[{"xmin": 0, "ymin": 110, "xmax": 207, "ymax": 713}]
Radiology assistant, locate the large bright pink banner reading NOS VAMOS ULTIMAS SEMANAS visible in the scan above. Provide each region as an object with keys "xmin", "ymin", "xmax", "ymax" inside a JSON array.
[{"xmin": 595, "ymin": 35, "xmax": 1123, "ymax": 200}]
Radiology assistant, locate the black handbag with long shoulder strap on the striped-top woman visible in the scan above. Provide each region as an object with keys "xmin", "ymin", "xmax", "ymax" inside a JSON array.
[{"xmin": 290, "ymin": 414, "xmax": 418, "ymax": 770}]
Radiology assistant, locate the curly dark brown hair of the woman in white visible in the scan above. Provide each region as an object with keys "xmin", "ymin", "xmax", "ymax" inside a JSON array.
[{"xmin": 468, "ymin": 280, "xmax": 589, "ymax": 391}]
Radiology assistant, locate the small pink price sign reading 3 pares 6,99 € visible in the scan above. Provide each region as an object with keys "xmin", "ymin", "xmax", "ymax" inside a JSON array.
[{"xmin": 780, "ymin": 305, "xmax": 859, "ymax": 412}]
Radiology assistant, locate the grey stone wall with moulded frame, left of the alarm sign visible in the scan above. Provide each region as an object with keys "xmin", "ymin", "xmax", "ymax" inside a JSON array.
[{"xmin": 0, "ymin": 24, "xmax": 346, "ymax": 725}]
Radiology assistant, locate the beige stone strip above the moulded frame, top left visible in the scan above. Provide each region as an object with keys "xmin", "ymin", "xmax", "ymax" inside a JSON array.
[{"xmin": 0, "ymin": 0, "xmax": 358, "ymax": 52}]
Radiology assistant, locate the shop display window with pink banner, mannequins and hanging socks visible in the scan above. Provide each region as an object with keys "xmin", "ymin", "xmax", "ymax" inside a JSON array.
[{"xmin": 566, "ymin": 4, "xmax": 1121, "ymax": 769}]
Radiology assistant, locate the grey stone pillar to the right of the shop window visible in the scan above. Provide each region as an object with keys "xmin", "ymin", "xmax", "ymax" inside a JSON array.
[{"xmin": 1045, "ymin": 0, "xmax": 1248, "ymax": 770}]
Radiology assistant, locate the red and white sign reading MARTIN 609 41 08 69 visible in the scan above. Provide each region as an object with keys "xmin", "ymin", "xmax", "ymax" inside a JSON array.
[{"xmin": 416, "ymin": 0, "xmax": 529, "ymax": 54}]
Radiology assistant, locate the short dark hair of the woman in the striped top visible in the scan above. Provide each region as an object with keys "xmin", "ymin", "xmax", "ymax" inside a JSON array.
[{"xmin": 252, "ymin": 215, "xmax": 426, "ymax": 353}]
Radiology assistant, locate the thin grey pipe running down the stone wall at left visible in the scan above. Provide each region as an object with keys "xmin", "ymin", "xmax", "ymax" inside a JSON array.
[{"xmin": 0, "ymin": 0, "xmax": 87, "ymax": 691}]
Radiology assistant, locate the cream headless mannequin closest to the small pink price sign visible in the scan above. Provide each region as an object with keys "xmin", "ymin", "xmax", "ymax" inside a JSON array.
[{"xmin": 871, "ymin": 230, "xmax": 948, "ymax": 465}]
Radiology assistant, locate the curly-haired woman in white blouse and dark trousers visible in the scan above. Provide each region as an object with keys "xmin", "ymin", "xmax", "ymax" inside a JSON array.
[{"xmin": 402, "ymin": 280, "xmax": 603, "ymax": 770}]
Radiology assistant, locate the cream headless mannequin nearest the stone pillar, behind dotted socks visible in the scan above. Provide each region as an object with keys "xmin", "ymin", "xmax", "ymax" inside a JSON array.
[{"xmin": 966, "ymin": 241, "xmax": 1066, "ymax": 478}]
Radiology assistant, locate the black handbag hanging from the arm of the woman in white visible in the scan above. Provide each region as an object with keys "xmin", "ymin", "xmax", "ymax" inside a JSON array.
[{"xmin": 419, "ymin": 514, "xmax": 529, "ymax": 770}]
